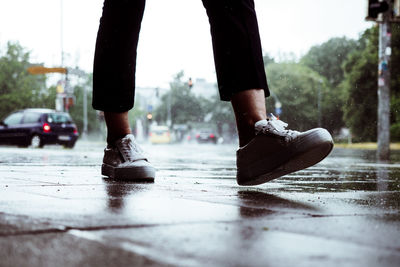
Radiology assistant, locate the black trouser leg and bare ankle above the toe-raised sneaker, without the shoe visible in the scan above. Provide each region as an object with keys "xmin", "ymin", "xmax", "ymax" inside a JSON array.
[{"xmin": 203, "ymin": 0, "xmax": 269, "ymax": 146}]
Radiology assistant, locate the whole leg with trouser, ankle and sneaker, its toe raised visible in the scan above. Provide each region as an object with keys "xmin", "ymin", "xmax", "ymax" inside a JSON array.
[{"xmin": 203, "ymin": 0, "xmax": 333, "ymax": 185}]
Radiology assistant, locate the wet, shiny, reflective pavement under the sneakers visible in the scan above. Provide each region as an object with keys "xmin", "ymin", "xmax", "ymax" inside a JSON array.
[{"xmin": 0, "ymin": 141, "xmax": 400, "ymax": 266}]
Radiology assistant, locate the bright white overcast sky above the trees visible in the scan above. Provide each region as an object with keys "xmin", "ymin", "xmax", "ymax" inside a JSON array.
[{"xmin": 0, "ymin": 0, "xmax": 372, "ymax": 87}]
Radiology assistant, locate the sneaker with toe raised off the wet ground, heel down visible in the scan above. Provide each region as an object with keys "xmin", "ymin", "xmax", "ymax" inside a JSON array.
[{"xmin": 236, "ymin": 116, "xmax": 333, "ymax": 185}]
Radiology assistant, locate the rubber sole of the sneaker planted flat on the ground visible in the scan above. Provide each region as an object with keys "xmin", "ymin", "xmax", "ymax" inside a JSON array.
[{"xmin": 101, "ymin": 163, "xmax": 156, "ymax": 182}]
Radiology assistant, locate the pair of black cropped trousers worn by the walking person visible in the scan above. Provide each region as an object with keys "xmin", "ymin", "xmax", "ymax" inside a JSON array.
[{"xmin": 92, "ymin": 0, "xmax": 269, "ymax": 112}]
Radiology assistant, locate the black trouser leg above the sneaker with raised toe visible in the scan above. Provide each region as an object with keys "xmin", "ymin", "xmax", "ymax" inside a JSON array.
[{"xmin": 202, "ymin": 0, "xmax": 269, "ymax": 101}]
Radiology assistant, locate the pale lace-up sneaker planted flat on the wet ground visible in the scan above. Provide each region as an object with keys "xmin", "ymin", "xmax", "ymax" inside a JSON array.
[{"xmin": 101, "ymin": 134, "xmax": 155, "ymax": 182}]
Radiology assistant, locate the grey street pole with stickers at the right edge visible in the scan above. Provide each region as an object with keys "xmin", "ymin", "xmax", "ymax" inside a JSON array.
[{"xmin": 377, "ymin": 4, "xmax": 392, "ymax": 161}]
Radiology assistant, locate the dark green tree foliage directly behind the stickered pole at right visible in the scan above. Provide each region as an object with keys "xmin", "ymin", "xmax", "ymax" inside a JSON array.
[{"xmin": 334, "ymin": 24, "xmax": 400, "ymax": 141}]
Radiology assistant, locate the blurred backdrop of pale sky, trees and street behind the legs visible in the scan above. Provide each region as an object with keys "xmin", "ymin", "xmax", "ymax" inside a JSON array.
[{"xmin": 0, "ymin": 0, "xmax": 400, "ymax": 147}]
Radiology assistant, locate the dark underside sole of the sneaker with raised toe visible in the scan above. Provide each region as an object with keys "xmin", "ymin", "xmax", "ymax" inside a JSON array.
[{"xmin": 237, "ymin": 130, "xmax": 333, "ymax": 186}]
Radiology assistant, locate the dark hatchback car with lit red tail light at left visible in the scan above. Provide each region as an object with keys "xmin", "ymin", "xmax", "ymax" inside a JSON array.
[{"xmin": 0, "ymin": 108, "xmax": 78, "ymax": 151}]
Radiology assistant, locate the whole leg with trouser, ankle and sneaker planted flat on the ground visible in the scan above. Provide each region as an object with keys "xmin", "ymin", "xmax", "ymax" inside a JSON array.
[{"xmin": 92, "ymin": 0, "xmax": 155, "ymax": 181}]
